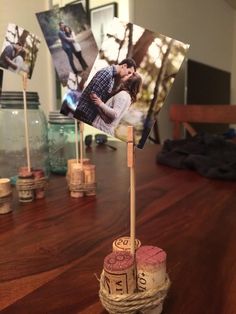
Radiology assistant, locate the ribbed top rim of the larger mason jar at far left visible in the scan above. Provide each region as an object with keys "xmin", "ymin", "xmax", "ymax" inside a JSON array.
[{"xmin": 0, "ymin": 91, "xmax": 40, "ymax": 109}]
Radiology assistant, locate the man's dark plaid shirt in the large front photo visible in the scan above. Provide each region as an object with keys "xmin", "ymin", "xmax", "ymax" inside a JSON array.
[{"xmin": 74, "ymin": 66, "xmax": 117, "ymax": 124}]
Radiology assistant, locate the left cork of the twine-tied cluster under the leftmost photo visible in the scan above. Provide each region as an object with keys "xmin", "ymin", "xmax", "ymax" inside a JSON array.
[{"xmin": 16, "ymin": 167, "xmax": 34, "ymax": 203}]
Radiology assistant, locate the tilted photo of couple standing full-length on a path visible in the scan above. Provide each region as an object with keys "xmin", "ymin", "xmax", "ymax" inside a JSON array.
[{"xmin": 36, "ymin": 3, "xmax": 98, "ymax": 86}]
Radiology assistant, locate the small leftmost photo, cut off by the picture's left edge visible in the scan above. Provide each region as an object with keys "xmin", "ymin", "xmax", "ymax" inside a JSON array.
[{"xmin": 0, "ymin": 24, "xmax": 40, "ymax": 79}]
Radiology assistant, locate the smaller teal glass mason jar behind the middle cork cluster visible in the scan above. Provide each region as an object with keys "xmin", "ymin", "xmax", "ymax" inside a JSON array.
[{"xmin": 48, "ymin": 111, "xmax": 78, "ymax": 175}]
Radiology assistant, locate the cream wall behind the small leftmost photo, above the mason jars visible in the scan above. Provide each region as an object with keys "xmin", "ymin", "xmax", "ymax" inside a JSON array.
[{"xmin": 0, "ymin": 0, "xmax": 55, "ymax": 114}]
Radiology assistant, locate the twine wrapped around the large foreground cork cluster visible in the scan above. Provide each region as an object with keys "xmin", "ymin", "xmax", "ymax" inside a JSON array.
[{"xmin": 99, "ymin": 273, "xmax": 170, "ymax": 314}]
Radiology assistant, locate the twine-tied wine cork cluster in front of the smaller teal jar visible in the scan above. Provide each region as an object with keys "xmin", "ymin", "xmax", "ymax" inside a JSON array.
[{"xmin": 66, "ymin": 159, "xmax": 96, "ymax": 198}]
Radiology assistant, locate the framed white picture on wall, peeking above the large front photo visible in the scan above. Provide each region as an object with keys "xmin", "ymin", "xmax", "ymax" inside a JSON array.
[{"xmin": 90, "ymin": 2, "xmax": 118, "ymax": 49}]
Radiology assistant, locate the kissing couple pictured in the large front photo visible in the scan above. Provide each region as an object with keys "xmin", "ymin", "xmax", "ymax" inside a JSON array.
[{"xmin": 74, "ymin": 58, "xmax": 142, "ymax": 136}]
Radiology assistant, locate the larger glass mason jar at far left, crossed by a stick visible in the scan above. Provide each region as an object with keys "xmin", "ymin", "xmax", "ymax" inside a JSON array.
[{"xmin": 0, "ymin": 91, "xmax": 49, "ymax": 183}]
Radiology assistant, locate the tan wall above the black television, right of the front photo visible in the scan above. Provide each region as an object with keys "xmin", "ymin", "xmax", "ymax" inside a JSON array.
[{"xmin": 133, "ymin": 0, "xmax": 236, "ymax": 141}]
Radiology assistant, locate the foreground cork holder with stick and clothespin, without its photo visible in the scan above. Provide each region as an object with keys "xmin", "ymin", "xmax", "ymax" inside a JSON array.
[{"xmin": 99, "ymin": 126, "xmax": 170, "ymax": 314}]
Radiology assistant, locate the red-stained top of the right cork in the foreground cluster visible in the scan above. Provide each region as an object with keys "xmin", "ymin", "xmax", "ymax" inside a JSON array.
[{"xmin": 136, "ymin": 245, "xmax": 166, "ymax": 265}]
